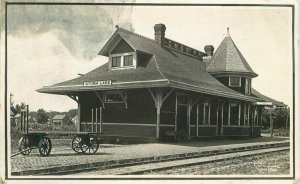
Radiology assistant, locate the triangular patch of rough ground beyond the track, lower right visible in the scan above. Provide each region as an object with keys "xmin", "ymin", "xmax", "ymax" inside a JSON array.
[{"xmin": 144, "ymin": 151, "xmax": 290, "ymax": 175}]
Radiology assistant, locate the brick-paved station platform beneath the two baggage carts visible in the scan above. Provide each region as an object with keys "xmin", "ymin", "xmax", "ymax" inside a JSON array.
[{"xmin": 11, "ymin": 137, "xmax": 289, "ymax": 176}]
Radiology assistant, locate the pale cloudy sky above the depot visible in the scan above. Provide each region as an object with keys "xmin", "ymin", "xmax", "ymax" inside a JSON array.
[{"xmin": 5, "ymin": 5, "xmax": 292, "ymax": 111}]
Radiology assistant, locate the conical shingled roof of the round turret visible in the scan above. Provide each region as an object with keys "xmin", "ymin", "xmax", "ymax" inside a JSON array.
[{"xmin": 207, "ymin": 35, "xmax": 258, "ymax": 77}]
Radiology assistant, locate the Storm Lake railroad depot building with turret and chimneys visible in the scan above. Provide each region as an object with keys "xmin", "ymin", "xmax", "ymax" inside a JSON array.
[{"xmin": 37, "ymin": 24, "xmax": 284, "ymax": 139}]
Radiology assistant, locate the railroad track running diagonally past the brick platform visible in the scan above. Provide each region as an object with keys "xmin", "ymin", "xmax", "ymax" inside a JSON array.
[{"xmin": 45, "ymin": 142, "xmax": 290, "ymax": 175}]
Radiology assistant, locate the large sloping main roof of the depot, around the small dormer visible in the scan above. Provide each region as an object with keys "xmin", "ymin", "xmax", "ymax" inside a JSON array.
[{"xmin": 37, "ymin": 28, "xmax": 256, "ymax": 102}]
